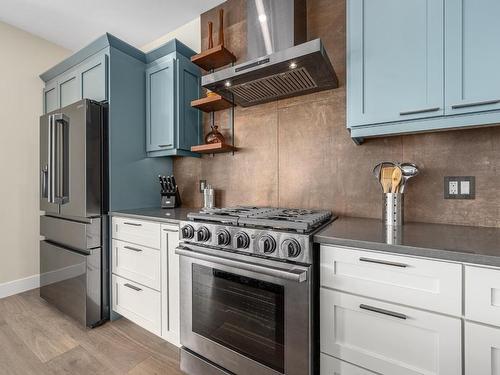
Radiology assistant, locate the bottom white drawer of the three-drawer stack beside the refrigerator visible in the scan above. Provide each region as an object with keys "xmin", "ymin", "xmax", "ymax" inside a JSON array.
[{"xmin": 112, "ymin": 275, "xmax": 161, "ymax": 336}]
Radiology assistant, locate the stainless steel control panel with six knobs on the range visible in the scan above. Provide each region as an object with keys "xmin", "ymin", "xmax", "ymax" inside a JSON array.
[{"xmin": 180, "ymin": 221, "xmax": 312, "ymax": 264}]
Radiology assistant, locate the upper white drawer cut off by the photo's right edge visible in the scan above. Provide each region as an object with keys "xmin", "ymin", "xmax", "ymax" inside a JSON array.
[{"xmin": 465, "ymin": 266, "xmax": 500, "ymax": 328}]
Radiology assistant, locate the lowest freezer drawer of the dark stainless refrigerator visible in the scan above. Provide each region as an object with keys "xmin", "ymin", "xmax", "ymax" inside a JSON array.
[{"xmin": 40, "ymin": 241, "xmax": 101, "ymax": 327}]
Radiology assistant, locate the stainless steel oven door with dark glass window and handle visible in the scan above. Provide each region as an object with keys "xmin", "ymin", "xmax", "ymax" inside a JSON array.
[{"xmin": 176, "ymin": 245, "xmax": 312, "ymax": 375}]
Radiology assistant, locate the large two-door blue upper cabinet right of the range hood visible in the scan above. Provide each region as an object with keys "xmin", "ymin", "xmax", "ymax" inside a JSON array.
[{"xmin": 347, "ymin": 0, "xmax": 500, "ymax": 143}]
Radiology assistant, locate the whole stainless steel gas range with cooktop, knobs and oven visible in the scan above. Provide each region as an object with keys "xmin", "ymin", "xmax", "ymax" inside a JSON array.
[{"xmin": 176, "ymin": 207, "xmax": 334, "ymax": 375}]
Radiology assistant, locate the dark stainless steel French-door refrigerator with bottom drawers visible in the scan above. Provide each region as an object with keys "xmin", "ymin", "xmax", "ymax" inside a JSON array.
[{"xmin": 40, "ymin": 100, "xmax": 109, "ymax": 327}]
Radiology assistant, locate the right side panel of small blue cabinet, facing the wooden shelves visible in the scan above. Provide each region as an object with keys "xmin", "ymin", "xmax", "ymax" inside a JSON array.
[{"xmin": 176, "ymin": 56, "xmax": 202, "ymax": 151}]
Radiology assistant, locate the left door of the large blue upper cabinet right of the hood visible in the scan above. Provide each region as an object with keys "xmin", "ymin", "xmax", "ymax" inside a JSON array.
[{"xmin": 347, "ymin": 0, "xmax": 444, "ymax": 127}]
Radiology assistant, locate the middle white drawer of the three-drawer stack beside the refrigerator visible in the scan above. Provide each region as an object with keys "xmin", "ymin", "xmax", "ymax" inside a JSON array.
[{"xmin": 111, "ymin": 240, "xmax": 161, "ymax": 291}]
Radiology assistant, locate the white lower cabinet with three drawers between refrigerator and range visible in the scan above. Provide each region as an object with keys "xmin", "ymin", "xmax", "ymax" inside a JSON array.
[{"xmin": 111, "ymin": 217, "xmax": 180, "ymax": 346}]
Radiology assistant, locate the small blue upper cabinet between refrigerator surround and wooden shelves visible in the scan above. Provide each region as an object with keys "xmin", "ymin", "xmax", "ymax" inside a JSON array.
[{"xmin": 146, "ymin": 52, "xmax": 202, "ymax": 157}]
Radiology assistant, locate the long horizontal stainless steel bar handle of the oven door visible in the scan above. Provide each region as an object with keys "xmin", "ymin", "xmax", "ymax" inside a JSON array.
[{"xmin": 175, "ymin": 247, "xmax": 307, "ymax": 283}]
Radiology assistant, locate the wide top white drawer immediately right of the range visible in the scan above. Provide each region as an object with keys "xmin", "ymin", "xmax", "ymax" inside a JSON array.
[{"xmin": 321, "ymin": 246, "xmax": 462, "ymax": 316}]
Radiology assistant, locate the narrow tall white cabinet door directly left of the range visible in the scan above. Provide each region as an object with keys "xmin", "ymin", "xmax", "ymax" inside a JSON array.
[{"xmin": 161, "ymin": 225, "xmax": 180, "ymax": 346}]
